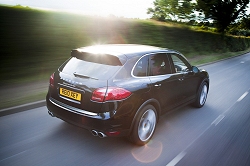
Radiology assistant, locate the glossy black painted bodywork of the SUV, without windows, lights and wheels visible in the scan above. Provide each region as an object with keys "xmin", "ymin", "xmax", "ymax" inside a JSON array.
[{"xmin": 46, "ymin": 45, "xmax": 209, "ymax": 136}]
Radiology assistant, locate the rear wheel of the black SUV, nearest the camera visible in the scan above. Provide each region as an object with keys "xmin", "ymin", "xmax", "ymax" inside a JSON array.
[{"xmin": 129, "ymin": 105, "xmax": 157, "ymax": 146}]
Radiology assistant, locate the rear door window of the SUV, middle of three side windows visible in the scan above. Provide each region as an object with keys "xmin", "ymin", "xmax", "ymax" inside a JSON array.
[{"xmin": 149, "ymin": 53, "xmax": 171, "ymax": 76}]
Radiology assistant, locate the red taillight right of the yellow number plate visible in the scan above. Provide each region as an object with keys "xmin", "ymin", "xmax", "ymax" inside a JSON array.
[{"xmin": 91, "ymin": 87, "xmax": 131, "ymax": 102}]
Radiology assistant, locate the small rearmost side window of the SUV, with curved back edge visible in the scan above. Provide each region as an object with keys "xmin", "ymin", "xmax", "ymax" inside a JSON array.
[{"xmin": 133, "ymin": 56, "xmax": 148, "ymax": 77}]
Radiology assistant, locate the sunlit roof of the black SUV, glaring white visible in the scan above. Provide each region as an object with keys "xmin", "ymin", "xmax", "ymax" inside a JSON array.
[{"xmin": 76, "ymin": 44, "xmax": 167, "ymax": 58}]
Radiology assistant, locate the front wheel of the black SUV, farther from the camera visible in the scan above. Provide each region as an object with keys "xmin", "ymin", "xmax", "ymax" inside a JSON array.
[{"xmin": 193, "ymin": 82, "xmax": 208, "ymax": 108}]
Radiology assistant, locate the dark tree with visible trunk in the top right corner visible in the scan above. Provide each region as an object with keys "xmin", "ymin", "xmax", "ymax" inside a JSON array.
[{"xmin": 196, "ymin": 0, "xmax": 249, "ymax": 32}]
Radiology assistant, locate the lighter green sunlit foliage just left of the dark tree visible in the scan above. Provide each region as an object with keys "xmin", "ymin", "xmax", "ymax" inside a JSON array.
[{"xmin": 147, "ymin": 0, "xmax": 195, "ymax": 21}]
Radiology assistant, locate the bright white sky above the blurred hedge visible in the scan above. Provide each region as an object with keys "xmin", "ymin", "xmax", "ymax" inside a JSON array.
[{"xmin": 0, "ymin": 0, "xmax": 154, "ymax": 19}]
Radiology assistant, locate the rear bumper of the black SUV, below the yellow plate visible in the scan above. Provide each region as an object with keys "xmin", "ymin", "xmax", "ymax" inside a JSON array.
[{"xmin": 46, "ymin": 95, "xmax": 131, "ymax": 136}]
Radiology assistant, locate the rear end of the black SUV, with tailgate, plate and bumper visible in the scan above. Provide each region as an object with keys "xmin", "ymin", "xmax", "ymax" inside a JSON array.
[{"xmin": 46, "ymin": 49, "xmax": 132, "ymax": 137}]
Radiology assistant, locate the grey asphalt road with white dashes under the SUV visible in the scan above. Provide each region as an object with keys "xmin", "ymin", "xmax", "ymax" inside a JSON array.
[{"xmin": 0, "ymin": 54, "xmax": 250, "ymax": 166}]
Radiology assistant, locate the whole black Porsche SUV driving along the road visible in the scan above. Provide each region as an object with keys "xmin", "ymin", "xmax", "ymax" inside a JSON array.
[{"xmin": 46, "ymin": 44, "xmax": 209, "ymax": 145}]
